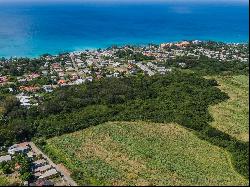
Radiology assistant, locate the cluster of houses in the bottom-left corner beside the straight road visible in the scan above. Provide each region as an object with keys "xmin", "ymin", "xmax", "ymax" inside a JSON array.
[{"xmin": 0, "ymin": 142, "xmax": 67, "ymax": 186}]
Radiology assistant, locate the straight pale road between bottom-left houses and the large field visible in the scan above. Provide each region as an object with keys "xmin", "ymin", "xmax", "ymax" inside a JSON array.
[{"xmin": 28, "ymin": 142, "xmax": 78, "ymax": 186}]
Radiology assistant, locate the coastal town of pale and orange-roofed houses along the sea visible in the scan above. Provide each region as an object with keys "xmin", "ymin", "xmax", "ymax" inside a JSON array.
[{"xmin": 0, "ymin": 40, "xmax": 249, "ymax": 108}]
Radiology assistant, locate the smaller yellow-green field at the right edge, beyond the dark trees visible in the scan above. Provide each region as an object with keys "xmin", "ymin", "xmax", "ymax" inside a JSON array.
[{"xmin": 209, "ymin": 75, "xmax": 249, "ymax": 142}]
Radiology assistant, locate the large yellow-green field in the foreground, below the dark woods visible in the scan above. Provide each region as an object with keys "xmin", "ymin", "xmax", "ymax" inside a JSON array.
[{"xmin": 46, "ymin": 122, "xmax": 248, "ymax": 185}]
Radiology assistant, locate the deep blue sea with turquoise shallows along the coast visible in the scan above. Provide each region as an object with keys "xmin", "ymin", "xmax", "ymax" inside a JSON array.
[{"xmin": 0, "ymin": 0, "xmax": 249, "ymax": 57}]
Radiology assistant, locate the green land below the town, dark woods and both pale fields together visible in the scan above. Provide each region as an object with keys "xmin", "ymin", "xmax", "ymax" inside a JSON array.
[{"xmin": 0, "ymin": 72, "xmax": 249, "ymax": 185}]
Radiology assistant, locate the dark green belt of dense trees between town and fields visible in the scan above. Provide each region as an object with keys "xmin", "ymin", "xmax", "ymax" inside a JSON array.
[{"xmin": 0, "ymin": 72, "xmax": 249, "ymax": 177}]
